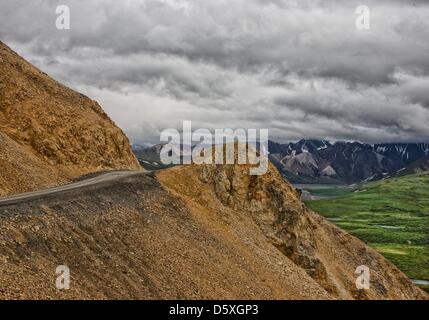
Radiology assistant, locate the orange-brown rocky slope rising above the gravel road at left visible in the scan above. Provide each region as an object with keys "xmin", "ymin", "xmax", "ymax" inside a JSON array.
[{"xmin": 0, "ymin": 42, "xmax": 139, "ymax": 195}]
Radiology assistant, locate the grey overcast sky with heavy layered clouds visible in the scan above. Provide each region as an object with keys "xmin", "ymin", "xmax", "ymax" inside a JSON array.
[{"xmin": 0, "ymin": 0, "xmax": 429, "ymax": 143}]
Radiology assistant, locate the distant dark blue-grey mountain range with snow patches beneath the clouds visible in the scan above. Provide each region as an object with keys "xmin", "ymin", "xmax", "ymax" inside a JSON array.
[{"xmin": 133, "ymin": 139, "xmax": 429, "ymax": 184}]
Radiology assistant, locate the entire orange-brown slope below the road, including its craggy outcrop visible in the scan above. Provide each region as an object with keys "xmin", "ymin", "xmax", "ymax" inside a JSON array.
[{"xmin": 0, "ymin": 165, "xmax": 427, "ymax": 299}]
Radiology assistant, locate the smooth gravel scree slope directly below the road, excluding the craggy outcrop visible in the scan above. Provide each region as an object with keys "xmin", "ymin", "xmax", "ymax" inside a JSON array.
[{"xmin": 0, "ymin": 173, "xmax": 330, "ymax": 299}]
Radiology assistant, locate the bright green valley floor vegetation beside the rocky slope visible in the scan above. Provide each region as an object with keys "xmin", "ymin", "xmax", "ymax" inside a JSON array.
[{"xmin": 307, "ymin": 172, "xmax": 429, "ymax": 280}]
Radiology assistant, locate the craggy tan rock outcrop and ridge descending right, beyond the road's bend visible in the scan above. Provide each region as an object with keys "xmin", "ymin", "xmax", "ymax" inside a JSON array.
[{"xmin": 157, "ymin": 165, "xmax": 425, "ymax": 299}]
